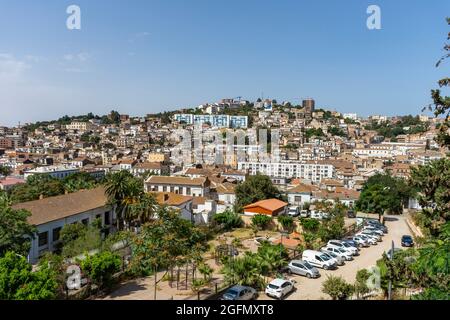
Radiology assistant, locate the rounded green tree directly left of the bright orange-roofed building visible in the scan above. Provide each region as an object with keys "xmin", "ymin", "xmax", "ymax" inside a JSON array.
[{"xmin": 235, "ymin": 174, "xmax": 284, "ymax": 210}]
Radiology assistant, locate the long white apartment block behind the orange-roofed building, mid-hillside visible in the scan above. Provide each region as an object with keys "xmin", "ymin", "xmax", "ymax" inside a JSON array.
[{"xmin": 238, "ymin": 161, "xmax": 335, "ymax": 182}]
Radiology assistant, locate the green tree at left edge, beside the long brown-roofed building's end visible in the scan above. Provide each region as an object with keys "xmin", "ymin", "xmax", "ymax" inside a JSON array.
[{"xmin": 0, "ymin": 194, "xmax": 36, "ymax": 256}]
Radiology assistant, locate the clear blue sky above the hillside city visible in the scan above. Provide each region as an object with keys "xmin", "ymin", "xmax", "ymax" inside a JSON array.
[{"xmin": 0, "ymin": 0, "xmax": 450, "ymax": 125}]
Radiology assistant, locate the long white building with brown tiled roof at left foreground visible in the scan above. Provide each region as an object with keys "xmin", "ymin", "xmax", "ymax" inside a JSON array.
[{"xmin": 13, "ymin": 187, "xmax": 115, "ymax": 263}]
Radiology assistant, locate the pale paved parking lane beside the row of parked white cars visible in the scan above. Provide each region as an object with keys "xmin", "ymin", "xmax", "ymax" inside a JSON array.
[{"xmin": 258, "ymin": 216, "xmax": 411, "ymax": 300}]
